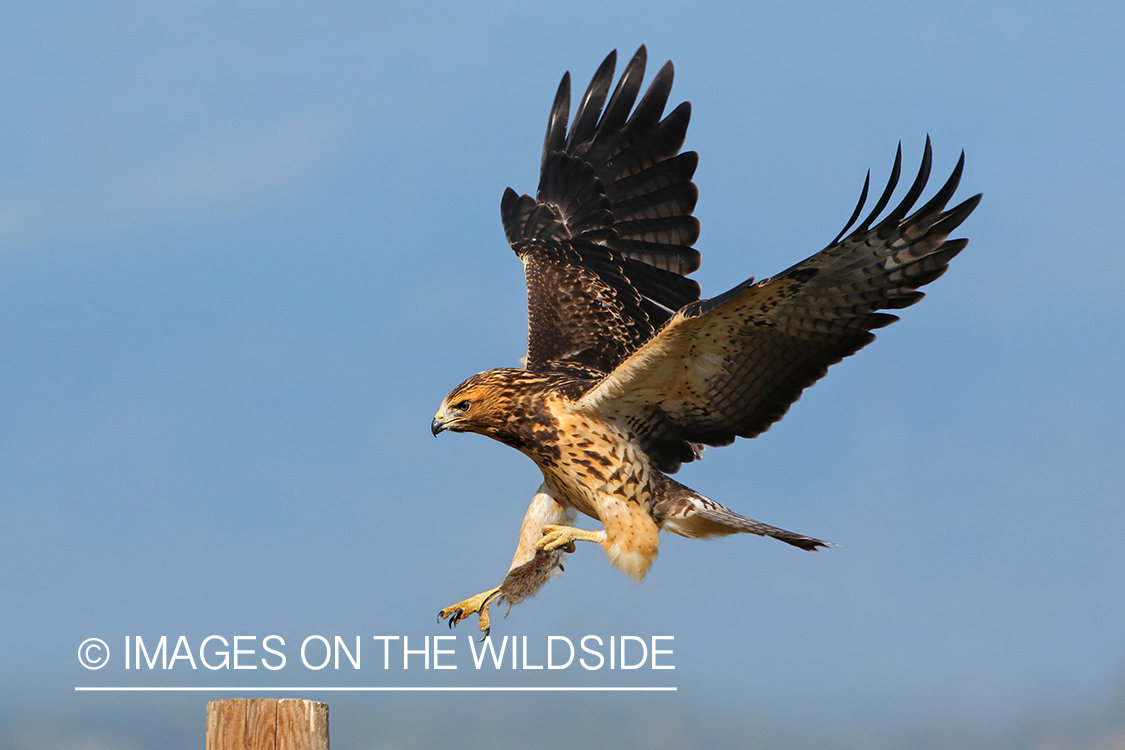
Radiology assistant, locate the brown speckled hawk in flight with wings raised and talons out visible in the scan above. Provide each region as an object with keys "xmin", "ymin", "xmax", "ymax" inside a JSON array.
[{"xmin": 431, "ymin": 46, "xmax": 980, "ymax": 634}]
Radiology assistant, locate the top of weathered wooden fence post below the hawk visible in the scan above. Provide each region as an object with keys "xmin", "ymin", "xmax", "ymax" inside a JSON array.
[{"xmin": 207, "ymin": 698, "xmax": 329, "ymax": 750}]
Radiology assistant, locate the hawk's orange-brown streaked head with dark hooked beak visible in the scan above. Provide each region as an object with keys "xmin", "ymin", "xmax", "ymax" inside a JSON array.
[{"xmin": 430, "ymin": 369, "xmax": 542, "ymax": 439}]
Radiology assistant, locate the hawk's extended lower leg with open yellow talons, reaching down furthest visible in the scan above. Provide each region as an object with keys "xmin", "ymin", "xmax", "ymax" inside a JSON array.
[{"xmin": 438, "ymin": 486, "xmax": 574, "ymax": 635}]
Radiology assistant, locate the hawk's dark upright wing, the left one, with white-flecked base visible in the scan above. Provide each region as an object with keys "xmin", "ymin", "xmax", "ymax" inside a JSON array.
[{"xmin": 501, "ymin": 46, "xmax": 700, "ymax": 372}]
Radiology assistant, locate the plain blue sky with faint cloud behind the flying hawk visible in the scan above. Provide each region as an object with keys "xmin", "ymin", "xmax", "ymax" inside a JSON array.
[{"xmin": 0, "ymin": 1, "xmax": 1125, "ymax": 750}]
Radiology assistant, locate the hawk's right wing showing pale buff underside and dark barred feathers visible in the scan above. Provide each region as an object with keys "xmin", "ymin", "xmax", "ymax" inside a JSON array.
[{"xmin": 578, "ymin": 138, "xmax": 980, "ymax": 471}]
